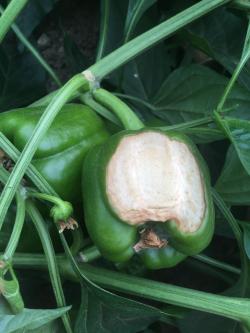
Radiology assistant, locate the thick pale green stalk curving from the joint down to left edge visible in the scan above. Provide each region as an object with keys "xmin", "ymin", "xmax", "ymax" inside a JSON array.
[{"xmin": 0, "ymin": 74, "xmax": 87, "ymax": 230}]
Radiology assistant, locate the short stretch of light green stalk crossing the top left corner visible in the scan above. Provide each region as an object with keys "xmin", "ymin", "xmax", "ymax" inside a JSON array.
[{"xmin": 0, "ymin": 0, "xmax": 29, "ymax": 43}]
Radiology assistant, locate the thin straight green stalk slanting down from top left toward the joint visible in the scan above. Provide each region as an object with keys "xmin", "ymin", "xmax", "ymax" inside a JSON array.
[{"xmin": 0, "ymin": 5, "xmax": 62, "ymax": 87}]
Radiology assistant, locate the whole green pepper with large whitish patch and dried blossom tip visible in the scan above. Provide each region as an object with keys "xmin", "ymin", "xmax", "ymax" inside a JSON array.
[{"xmin": 83, "ymin": 87, "xmax": 214, "ymax": 269}]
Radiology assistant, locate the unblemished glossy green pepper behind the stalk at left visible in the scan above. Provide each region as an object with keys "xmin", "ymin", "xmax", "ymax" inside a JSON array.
[{"xmin": 0, "ymin": 104, "xmax": 109, "ymax": 204}]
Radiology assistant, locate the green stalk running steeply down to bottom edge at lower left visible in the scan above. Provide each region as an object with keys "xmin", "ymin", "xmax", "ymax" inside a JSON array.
[{"xmin": 26, "ymin": 200, "xmax": 73, "ymax": 333}]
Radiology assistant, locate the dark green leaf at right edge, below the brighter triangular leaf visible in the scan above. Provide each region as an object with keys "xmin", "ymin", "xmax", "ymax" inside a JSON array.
[{"xmin": 215, "ymin": 146, "xmax": 250, "ymax": 205}]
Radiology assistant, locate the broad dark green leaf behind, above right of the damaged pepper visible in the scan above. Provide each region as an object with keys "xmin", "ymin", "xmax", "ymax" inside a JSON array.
[{"xmin": 153, "ymin": 65, "xmax": 250, "ymax": 124}]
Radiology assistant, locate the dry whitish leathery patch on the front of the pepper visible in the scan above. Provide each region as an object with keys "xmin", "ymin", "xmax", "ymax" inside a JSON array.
[{"xmin": 106, "ymin": 131, "xmax": 206, "ymax": 232}]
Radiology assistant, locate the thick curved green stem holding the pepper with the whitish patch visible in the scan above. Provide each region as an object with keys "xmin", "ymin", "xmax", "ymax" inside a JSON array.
[{"xmin": 92, "ymin": 88, "xmax": 144, "ymax": 130}]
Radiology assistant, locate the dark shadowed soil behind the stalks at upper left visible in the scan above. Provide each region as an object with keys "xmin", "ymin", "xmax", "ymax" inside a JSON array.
[{"xmin": 37, "ymin": 0, "xmax": 100, "ymax": 91}]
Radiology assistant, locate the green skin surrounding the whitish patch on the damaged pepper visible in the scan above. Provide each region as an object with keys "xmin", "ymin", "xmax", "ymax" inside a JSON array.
[{"xmin": 83, "ymin": 129, "xmax": 214, "ymax": 269}]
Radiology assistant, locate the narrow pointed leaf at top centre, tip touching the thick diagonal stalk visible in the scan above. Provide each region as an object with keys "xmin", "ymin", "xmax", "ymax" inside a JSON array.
[{"xmin": 124, "ymin": 0, "xmax": 156, "ymax": 42}]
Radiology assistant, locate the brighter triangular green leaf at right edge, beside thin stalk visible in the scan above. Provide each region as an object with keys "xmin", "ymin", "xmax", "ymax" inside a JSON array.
[{"xmin": 217, "ymin": 114, "xmax": 250, "ymax": 175}]
